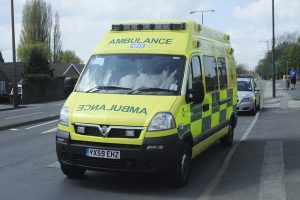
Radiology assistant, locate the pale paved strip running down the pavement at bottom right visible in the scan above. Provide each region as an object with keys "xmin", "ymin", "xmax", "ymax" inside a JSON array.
[{"xmin": 258, "ymin": 141, "xmax": 286, "ymax": 200}]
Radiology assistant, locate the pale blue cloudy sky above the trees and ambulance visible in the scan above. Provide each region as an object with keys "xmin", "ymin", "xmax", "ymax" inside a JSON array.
[{"xmin": 0, "ymin": 0, "xmax": 300, "ymax": 70}]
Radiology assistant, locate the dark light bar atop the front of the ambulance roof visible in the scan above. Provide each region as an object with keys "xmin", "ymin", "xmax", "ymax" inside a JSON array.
[{"xmin": 111, "ymin": 23, "xmax": 186, "ymax": 31}]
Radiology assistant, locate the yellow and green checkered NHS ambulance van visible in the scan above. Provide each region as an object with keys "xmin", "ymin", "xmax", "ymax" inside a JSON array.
[{"xmin": 56, "ymin": 20, "xmax": 237, "ymax": 186}]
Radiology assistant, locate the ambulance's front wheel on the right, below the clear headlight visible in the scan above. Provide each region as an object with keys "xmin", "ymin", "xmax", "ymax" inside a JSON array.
[{"xmin": 169, "ymin": 143, "xmax": 192, "ymax": 187}]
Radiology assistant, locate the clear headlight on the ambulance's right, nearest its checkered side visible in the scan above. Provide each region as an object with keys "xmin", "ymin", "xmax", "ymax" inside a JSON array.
[{"xmin": 148, "ymin": 113, "xmax": 176, "ymax": 131}]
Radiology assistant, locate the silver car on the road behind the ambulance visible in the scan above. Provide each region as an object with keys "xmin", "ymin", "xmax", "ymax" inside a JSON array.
[{"xmin": 237, "ymin": 78, "xmax": 261, "ymax": 115}]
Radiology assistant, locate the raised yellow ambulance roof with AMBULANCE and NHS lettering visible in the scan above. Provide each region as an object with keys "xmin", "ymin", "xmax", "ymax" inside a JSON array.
[{"xmin": 94, "ymin": 20, "xmax": 229, "ymax": 54}]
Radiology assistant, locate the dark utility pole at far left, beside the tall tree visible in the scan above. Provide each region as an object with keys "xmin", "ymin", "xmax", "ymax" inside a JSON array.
[{"xmin": 11, "ymin": 0, "xmax": 19, "ymax": 108}]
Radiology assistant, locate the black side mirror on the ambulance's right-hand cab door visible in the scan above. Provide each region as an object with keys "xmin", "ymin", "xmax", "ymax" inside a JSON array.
[{"xmin": 186, "ymin": 80, "xmax": 204, "ymax": 103}]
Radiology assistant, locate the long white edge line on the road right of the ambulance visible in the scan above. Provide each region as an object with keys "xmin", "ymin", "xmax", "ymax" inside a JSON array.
[{"xmin": 198, "ymin": 112, "xmax": 260, "ymax": 200}]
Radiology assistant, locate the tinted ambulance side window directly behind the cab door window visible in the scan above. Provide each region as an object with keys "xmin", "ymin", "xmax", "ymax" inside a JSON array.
[{"xmin": 203, "ymin": 56, "xmax": 219, "ymax": 92}]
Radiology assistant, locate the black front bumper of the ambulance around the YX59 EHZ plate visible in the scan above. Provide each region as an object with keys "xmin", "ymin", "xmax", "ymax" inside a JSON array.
[{"xmin": 56, "ymin": 131, "xmax": 181, "ymax": 173}]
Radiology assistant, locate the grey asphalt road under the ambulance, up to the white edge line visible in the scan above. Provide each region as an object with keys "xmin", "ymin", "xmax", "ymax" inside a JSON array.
[{"xmin": 0, "ymin": 111, "xmax": 254, "ymax": 200}]
